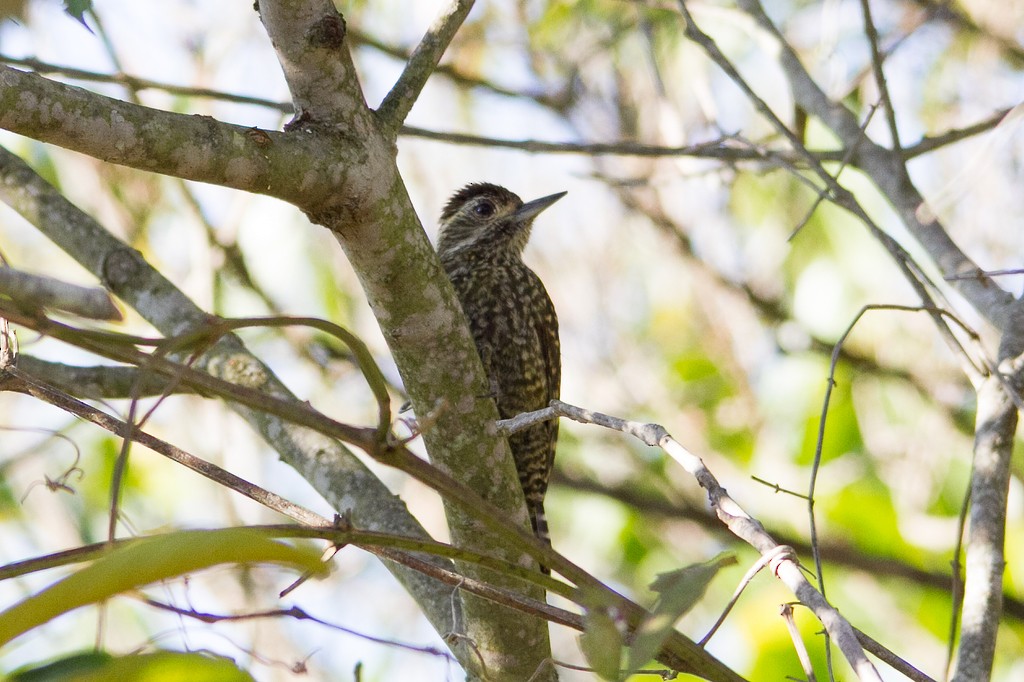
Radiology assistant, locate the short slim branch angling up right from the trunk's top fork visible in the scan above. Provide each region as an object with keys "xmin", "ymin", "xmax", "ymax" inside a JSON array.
[{"xmin": 377, "ymin": 0, "xmax": 473, "ymax": 139}]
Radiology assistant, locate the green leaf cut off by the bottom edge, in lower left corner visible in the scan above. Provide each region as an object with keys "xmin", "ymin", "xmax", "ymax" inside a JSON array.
[{"xmin": 7, "ymin": 651, "xmax": 253, "ymax": 682}]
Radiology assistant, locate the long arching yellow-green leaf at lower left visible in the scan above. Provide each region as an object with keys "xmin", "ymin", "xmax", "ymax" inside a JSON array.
[{"xmin": 0, "ymin": 528, "xmax": 328, "ymax": 646}]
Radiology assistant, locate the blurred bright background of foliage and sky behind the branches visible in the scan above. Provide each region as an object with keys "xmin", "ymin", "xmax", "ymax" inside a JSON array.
[{"xmin": 0, "ymin": 0, "xmax": 1024, "ymax": 681}]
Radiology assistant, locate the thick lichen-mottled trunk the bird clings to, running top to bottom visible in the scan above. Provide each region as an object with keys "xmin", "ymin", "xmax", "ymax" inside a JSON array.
[{"xmin": 259, "ymin": 0, "xmax": 551, "ymax": 681}]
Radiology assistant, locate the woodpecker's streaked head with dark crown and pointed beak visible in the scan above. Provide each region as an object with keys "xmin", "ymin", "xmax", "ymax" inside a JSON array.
[{"xmin": 437, "ymin": 182, "xmax": 565, "ymax": 256}]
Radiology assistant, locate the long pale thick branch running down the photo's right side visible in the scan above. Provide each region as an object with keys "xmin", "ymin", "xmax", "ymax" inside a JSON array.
[{"xmin": 712, "ymin": 0, "xmax": 1024, "ymax": 680}]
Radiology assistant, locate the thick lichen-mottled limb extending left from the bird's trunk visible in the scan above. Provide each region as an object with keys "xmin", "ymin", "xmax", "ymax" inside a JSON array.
[{"xmin": 0, "ymin": 66, "xmax": 356, "ymax": 208}]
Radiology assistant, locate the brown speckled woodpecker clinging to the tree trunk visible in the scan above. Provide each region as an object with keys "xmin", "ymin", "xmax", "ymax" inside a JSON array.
[{"xmin": 437, "ymin": 182, "xmax": 565, "ymax": 557}]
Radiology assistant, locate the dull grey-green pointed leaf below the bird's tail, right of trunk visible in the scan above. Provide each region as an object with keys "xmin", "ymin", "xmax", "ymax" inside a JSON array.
[{"xmin": 626, "ymin": 553, "xmax": 736, "ymax": 676}]
